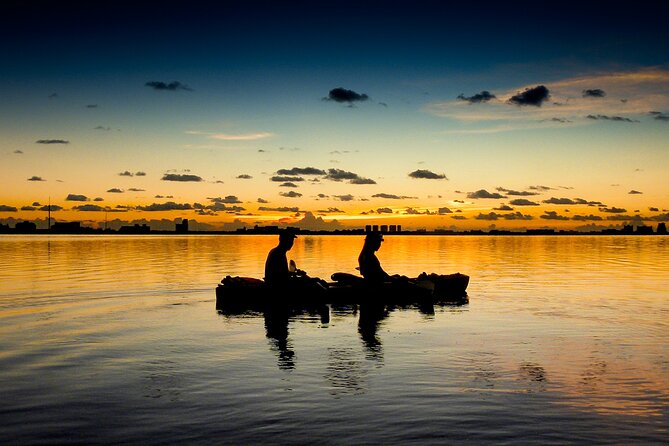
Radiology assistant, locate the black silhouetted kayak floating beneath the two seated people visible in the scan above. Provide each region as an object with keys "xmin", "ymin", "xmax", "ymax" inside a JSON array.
[{"xmin": 216, "ymin": 273, "xmax": 469, "ymax": 310}]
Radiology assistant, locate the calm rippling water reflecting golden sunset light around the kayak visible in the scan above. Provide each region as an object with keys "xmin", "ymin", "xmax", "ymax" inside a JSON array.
[{"xmin": 0, "ymin": 236, "xmax": 669, "ymax": 444}]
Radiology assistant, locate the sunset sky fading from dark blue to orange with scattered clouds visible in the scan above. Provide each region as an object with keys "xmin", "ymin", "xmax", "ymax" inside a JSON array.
[{"xmin": 0, "ymin": 0, "xmax": 669, "ymax": 230}]
